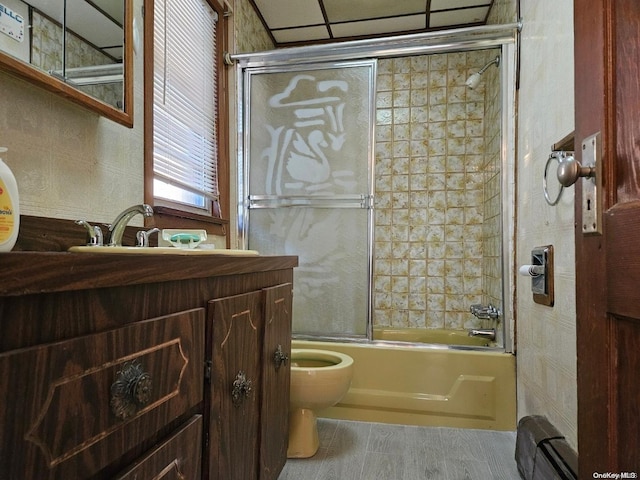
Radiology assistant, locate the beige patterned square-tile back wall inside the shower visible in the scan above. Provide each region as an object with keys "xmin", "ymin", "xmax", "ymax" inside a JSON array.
[{"xmin": 373, "ymin": 51, "xmax": 502, "ymax": 329}]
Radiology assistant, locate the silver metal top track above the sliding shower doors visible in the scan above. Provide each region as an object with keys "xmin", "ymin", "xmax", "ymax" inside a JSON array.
[{"xmin": 229, "ymin": 22, "xmax": 522, "ymax": 68}]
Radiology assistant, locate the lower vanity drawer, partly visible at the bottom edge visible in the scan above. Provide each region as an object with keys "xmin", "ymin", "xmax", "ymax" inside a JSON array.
[{"xmin": 115, "ymin": 415, "xmax": 202, "ymax": 480}]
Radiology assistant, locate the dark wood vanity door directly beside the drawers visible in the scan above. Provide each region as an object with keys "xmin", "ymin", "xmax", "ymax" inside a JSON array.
[{"xmin": 208, "ymin": 291, "xmax": 264, "ymax": 480}]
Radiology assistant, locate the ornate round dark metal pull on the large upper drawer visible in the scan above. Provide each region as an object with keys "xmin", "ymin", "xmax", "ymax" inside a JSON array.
[{"xmin": 110, "ymin": 360, "xmax": 152, "ymax": 420}]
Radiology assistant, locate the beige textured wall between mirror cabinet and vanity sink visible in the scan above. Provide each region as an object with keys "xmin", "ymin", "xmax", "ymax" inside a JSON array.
[{"xmin": 0, "ymin": 0, "xmax": 143, "ymax": 222}]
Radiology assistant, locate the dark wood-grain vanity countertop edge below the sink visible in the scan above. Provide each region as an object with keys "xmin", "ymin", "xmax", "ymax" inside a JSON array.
[{"xmin": 0, "ymin": 252, "xmax": 298, "ymax": 296}]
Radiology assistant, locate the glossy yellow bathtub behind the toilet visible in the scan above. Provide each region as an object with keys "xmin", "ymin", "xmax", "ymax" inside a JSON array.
[{"xmin": 292, "ymin": 340, "xmax": 516, "ymax": 431}]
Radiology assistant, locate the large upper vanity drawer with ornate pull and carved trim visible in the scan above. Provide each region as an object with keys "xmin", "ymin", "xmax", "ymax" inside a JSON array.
[{"xmin": 0, "ymin": 308, "xmax": 204, "ymax": 480}]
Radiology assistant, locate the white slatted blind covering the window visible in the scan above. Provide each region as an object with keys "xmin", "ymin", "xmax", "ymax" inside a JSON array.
[{"xmin": 153, "ymin": 0, "xmax": 218, "ymax": 208}]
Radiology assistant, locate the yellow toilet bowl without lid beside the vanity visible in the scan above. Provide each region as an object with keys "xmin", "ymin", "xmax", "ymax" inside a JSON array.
[{"xmin": 287, "ymin": 348, "xmax": 353, "ymax": 458}]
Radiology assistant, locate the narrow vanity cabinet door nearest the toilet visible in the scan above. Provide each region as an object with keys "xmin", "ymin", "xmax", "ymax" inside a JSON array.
[{"xmin": 260, "ymin": 283, "xmax": 292, "ymax": 480}]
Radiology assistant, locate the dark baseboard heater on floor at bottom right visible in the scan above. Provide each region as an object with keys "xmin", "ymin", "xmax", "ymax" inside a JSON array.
[{"xmin": 516, "ymin": 415, "xmax": 578, "ymax": 480}]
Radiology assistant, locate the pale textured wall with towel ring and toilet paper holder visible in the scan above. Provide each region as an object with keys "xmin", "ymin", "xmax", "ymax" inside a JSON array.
[{"xmin": 516, "ymin": 0, "xmax": 580, "ymax": 448}]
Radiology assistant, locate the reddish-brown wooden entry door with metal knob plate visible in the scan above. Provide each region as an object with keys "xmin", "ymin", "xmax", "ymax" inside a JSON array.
[{"xmin": 576, "ymin": 0, "xmax": 640, "ymax": 472}]
